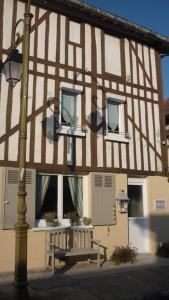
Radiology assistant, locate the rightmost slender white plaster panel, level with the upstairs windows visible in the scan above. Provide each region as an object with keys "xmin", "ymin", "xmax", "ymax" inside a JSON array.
[{"xmin": 154, "ymin": 104, "xmax": 161, "ymax": 155}]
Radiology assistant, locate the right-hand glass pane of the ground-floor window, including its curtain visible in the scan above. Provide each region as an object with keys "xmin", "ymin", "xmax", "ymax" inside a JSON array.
[{"xmin": 63, "ymin": 176, "xmax": 83, "ymax": 218}]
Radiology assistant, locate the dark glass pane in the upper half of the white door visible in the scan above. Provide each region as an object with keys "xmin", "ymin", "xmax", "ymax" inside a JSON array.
[{"xmin": 128, "ymin": 185, "xmax": 144, "ymax": 217}]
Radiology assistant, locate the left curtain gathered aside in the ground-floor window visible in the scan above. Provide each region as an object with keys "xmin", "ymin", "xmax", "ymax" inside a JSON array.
[{"xmin": 36, "ymin": 175, "xmax": 50, "ymax": 217}]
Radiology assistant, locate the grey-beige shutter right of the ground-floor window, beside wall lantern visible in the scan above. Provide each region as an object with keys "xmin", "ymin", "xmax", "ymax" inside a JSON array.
[{"xmin": 91, "ymin": 173, "xmax": 115, "ymax": 225}]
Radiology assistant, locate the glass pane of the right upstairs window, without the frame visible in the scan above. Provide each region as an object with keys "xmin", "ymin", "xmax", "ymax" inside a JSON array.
[{"xmin": 108, "ymin": 101, "xmax": 119, "ymax": 133}]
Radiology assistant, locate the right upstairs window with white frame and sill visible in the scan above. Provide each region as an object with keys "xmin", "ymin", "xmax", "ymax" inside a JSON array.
[{"xmin": 105, "ymin": 93, "xmax": 129, "ymax": 143}]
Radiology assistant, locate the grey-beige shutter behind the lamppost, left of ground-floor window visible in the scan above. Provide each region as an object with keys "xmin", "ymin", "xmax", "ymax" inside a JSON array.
[{"xmin": 2, "ymin": 168, "xmax": 36, "ymax": 229}]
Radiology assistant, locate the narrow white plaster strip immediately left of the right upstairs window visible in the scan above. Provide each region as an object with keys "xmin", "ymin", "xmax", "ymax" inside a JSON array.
[{"xmin": 97, "ymin": 90, "xmax": 103, "ymax": 167}]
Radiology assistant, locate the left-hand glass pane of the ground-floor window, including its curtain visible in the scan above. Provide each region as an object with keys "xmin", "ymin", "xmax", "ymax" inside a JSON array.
[{"xmin": 36, "ymin": 175, "xmax": 58, "ymax": 219}]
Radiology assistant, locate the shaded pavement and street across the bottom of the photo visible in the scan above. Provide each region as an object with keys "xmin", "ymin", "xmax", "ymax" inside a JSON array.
[{"xmin": 0, "ymin": 256, "xmax": 169, "ymax": 300}]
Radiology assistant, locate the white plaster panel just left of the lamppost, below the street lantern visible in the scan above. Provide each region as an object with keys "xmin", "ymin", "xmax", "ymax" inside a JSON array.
[{"xmin": 11, "ymin": 82, "xmax": 21, "ymax": 128}]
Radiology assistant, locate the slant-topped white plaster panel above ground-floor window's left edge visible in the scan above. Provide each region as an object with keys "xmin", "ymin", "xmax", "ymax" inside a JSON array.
[{"xmin": 34, "ymin": 113, "xmax": 43, "ymax": 163}]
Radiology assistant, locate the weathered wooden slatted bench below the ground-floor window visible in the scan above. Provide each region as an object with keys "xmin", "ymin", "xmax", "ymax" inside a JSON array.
[{"xmin": 46, "ymin": 228, "xmax": 100, "ymax": 273}]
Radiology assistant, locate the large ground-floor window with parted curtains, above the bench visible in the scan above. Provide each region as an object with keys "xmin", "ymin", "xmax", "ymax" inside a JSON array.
[{"xmin": 36, "ymin": 174, "xmax": 84, "ymax": 220}]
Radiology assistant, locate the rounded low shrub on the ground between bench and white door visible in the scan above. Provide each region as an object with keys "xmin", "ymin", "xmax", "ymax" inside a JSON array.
[{"xmin": 110, "ymin": 246, "xmax": 137, "ymax": 265}]
